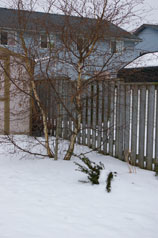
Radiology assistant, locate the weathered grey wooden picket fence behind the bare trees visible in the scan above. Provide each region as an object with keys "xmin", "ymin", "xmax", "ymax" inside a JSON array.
[{"xmin": 33, "ymin": 79, "xmax": 158, "ymax": 170}]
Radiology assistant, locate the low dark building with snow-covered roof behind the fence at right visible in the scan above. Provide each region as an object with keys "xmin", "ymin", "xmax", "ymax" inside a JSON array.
[{"xmin": 118, "ymin": 52, "xmax": 158, "ymax": 83}]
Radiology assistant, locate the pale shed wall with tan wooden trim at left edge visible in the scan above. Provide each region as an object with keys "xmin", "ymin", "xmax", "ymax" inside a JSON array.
[{"xmin": 0, "ymin": 47, "xmax": 31, "ymax": 134}]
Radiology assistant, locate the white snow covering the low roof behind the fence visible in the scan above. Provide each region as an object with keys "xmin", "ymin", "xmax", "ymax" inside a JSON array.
[{"xmin": 125, "ymin": 52, "xmax": 158, "ymax": 69}]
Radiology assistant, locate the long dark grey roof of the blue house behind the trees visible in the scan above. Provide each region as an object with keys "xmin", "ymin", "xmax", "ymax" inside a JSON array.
[{"xmin": 0, "ymin": 8, "xmax": 140, "ymax": 41}]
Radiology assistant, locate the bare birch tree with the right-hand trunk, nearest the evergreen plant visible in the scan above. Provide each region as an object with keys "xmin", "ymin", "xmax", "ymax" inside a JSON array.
[{"xmin": 43, "ymin": 0, "xmax": 143, "ymax": 160}]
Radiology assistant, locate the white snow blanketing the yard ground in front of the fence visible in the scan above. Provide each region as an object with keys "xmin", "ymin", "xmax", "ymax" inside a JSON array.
[{"xmin": 0, "ymin": 136, "xmax": 158, "ymax": 238}]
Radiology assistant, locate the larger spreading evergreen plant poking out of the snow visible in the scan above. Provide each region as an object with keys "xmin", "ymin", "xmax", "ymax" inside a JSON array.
[{"xmin": 74, "ymin": 155, "xmax": 104, "ymax": 184}]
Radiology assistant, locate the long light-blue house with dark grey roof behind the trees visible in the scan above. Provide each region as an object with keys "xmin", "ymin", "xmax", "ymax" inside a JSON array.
[{"xmin": 0, "ymin": 8, "xmax": 140, "ymax": 78}]
